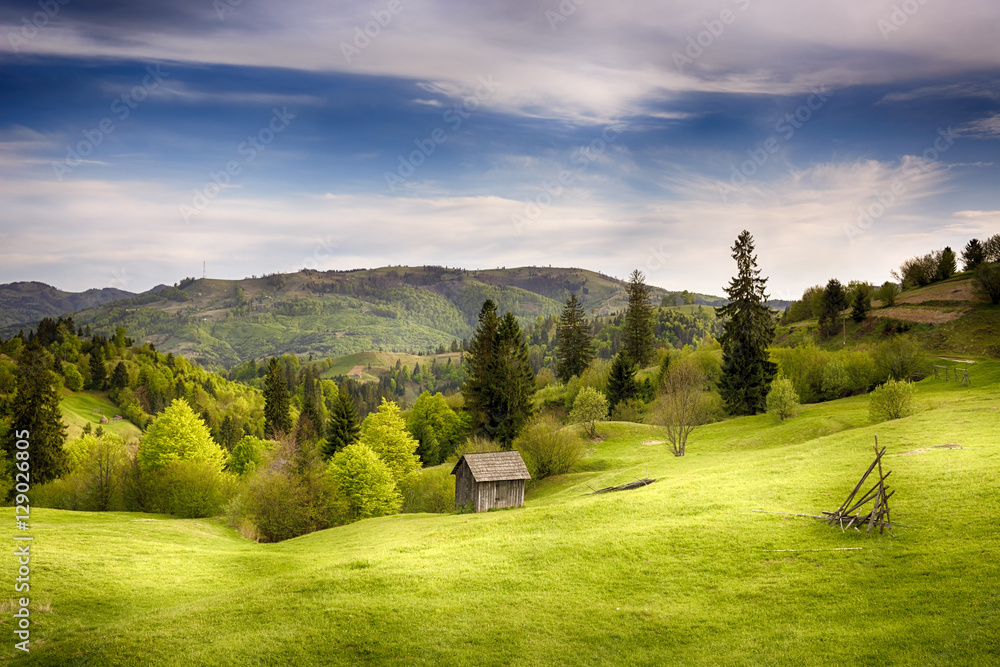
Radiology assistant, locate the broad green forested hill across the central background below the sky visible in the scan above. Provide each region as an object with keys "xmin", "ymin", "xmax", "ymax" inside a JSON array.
[{"xmin": 4, "ymin": 267, "xmax": 720, "ymax": 367}]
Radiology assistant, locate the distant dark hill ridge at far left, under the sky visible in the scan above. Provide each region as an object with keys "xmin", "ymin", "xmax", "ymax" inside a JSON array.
[{"xmin": 0, "ymin": 282, "xmax": 135, "ymax": 333}]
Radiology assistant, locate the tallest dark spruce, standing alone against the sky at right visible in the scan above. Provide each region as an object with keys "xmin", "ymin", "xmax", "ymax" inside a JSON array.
[{"xmin": 718, "ymin": 230, "xmax": 777, "ymax": 415}]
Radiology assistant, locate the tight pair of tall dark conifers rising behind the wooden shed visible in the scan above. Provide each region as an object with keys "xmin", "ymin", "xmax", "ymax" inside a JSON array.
[{"xmin": 462, "ymin": 299, "xmax": 535, "ymax": 449}]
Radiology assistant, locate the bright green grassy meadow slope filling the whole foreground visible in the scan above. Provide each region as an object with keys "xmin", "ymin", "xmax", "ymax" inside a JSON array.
[{"xmin": 0, "ymin": 362, "xmax": 1000, "ymax": 665}]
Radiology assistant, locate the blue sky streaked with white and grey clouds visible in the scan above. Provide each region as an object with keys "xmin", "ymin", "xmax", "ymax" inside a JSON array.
[{"xmin": 0, "ymin": 0, "xmax": 1000, "ymax": 299}]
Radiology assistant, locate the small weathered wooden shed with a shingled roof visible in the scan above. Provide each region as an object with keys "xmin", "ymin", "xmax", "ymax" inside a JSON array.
[{"xmin": 451, "ymin": 451, "xmax": 531, "ymax": 512}]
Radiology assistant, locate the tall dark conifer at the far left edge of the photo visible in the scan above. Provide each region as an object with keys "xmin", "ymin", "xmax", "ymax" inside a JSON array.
[{"xmin": 4, "ymin": 341, "xmax": 66, "ymax": 485}]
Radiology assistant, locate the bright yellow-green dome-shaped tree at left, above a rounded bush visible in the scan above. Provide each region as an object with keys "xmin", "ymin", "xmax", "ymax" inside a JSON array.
[{"xmin": 139, "ymin": 398, "xmax": 226, "ymax": 472}]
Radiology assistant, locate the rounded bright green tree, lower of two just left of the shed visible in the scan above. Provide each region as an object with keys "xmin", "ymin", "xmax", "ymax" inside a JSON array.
[{"xmin": 330, "ymin": 444, "xmax": 404, "ymax": 520}]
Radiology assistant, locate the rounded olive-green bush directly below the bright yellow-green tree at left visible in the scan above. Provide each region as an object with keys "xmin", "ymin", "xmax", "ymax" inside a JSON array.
[{"xmin": 146, "ymin": 461, "xmax": 236, "ymax": 519}]
